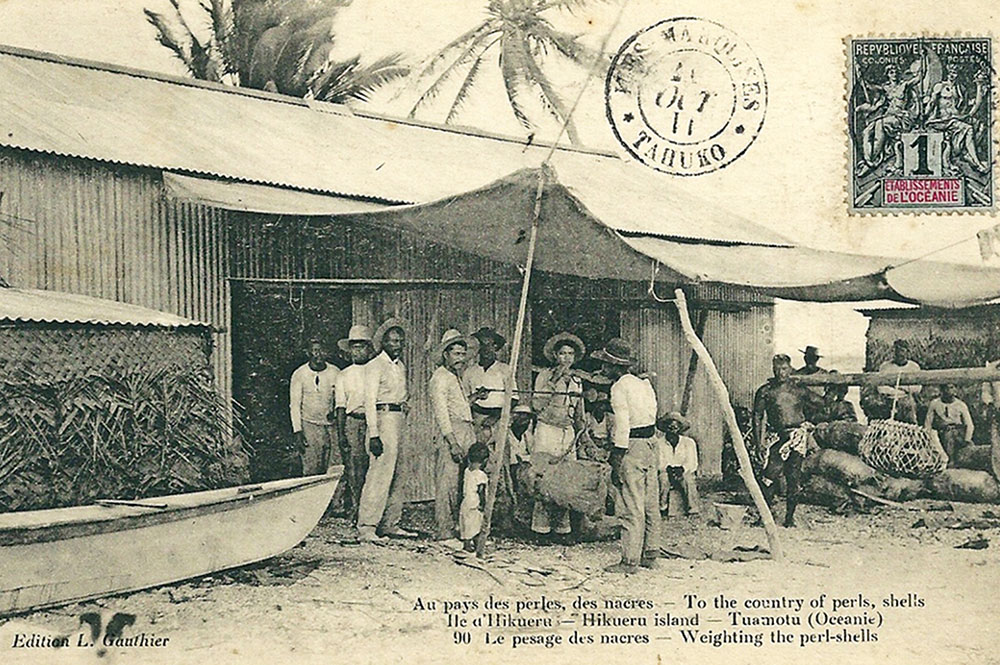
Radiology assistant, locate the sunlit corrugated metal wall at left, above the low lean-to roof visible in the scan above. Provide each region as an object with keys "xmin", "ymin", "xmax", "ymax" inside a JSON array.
[{"xmin": 0, "ymin": 148, "xmax": 231, "ymax": 396}]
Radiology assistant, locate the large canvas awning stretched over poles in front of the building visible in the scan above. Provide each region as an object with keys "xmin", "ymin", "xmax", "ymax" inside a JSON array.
[{"xmin": 164, "ymin": 167, "xmax": 1000, "ymax": 308}]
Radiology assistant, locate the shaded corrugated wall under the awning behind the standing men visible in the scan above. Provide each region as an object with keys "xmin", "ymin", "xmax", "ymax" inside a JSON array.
[{"xmin": 224, "ymin": 214, "xmax": 531, "ymax": 501}]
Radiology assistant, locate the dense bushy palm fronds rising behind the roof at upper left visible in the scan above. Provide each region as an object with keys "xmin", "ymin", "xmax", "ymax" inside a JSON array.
[{"xmin": 143, "ymin": 0, "xmax": 409, "ymax": 103}]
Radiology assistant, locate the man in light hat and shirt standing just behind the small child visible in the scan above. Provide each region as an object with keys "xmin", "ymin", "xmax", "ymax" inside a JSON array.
[{"xmin": 429, "ymin": 328, "xmax": 476, "ymax": 540}]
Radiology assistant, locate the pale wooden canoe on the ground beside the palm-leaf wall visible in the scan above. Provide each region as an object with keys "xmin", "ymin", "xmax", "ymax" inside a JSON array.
[{"xmin": 0, "ymin": 466, "xmax": 343, "ymax": 616}]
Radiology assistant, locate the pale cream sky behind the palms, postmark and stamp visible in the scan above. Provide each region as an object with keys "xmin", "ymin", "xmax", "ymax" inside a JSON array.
[{"xmin": 0, "ymin": 0, "xmax": 1000, "ymax": 369}]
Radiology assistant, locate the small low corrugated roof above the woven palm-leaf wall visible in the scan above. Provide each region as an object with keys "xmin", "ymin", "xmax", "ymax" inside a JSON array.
[{"xmin": 0, "ymin": 288, "xmax": 210, "ymax": 328}]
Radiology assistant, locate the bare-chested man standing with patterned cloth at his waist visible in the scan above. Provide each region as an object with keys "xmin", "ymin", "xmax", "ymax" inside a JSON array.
[{"xmin": 753, "ymin": 354, "xmax": 823, "ymax": 526}]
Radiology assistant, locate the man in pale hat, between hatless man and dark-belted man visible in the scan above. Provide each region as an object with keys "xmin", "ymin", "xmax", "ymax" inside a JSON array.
[{"xmin": 335, "ymin": 326, "xmax": 372, "ymax": 521}]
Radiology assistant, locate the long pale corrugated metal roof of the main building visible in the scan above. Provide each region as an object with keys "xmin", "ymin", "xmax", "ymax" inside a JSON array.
[{"xmin": 0, "ymin": 47, "xmax": 787, "ymax": 243}]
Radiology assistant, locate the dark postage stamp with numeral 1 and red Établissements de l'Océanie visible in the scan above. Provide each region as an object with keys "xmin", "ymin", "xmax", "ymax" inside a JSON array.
[{"xmin": 847, "ymin": 37, "xmax": 995, "ymax": 213}]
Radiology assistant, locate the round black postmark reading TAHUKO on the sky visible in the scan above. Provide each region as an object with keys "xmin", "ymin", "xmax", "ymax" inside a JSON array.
[{"xmin": 604, "ymin": 17, "xmax": 767, "ymax": 175}]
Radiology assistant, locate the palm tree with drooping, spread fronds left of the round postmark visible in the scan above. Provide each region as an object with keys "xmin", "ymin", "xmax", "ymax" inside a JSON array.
[{"xmin": 410, "ymin": 0, "xmax": 600, "ymax": 144}]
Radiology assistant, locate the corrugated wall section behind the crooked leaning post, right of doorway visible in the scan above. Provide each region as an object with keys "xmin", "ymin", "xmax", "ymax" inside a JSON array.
[{"xmin": 622, "ymin": 293, "xmax": 774, "ymax": 475}]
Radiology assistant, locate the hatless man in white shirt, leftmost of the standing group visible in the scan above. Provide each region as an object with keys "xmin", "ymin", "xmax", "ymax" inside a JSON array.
[{"xmin": 289, "ymin": 339, "xmax": 340, "ymax": 476}]
